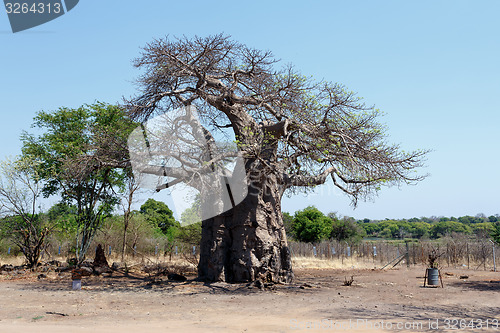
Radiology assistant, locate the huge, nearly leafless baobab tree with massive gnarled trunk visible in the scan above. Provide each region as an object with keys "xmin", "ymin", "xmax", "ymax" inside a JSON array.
[{"xmin": 127, "ymin": 35, "xmax": 426, "ymax": 282}]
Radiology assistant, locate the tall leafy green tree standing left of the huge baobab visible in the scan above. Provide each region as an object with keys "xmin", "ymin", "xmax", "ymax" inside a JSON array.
[{"xmin": 22, "ymin": 103, "xmax": 135, "ymax": 262}]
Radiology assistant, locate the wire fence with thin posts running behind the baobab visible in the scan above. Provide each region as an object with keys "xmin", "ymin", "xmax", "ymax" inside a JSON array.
[{"xmin": 0, "ymin": 238, "xmax": 500, "ymax": 270}]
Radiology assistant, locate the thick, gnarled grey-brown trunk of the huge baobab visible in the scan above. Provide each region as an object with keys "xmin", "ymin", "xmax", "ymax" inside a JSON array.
[{"xmin": 198, "ymin": 171, "xmax": 293, "ymax": 283}]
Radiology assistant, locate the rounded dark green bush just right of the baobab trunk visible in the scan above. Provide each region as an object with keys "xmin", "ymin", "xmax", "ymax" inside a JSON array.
[{"xmin": 293, "ymin": 206, "xmax": 332, "ymax": 243}]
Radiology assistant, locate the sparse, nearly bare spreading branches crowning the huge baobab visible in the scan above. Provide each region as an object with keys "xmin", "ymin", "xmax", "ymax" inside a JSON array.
[{"xmin": 129, "ymin": 35, "xmax": 426, "ymax": 204}]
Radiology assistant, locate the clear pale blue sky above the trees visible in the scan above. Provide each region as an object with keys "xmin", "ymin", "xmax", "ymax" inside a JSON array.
[{"xmin": 0, "ymin": 0, "xmax": 500, "ymax": 219}]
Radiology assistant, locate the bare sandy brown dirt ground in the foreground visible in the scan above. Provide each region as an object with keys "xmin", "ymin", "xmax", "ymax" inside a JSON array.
[{"xmin": 0, "ymin": 260, "xmax": 500, "ymax": 333}]
